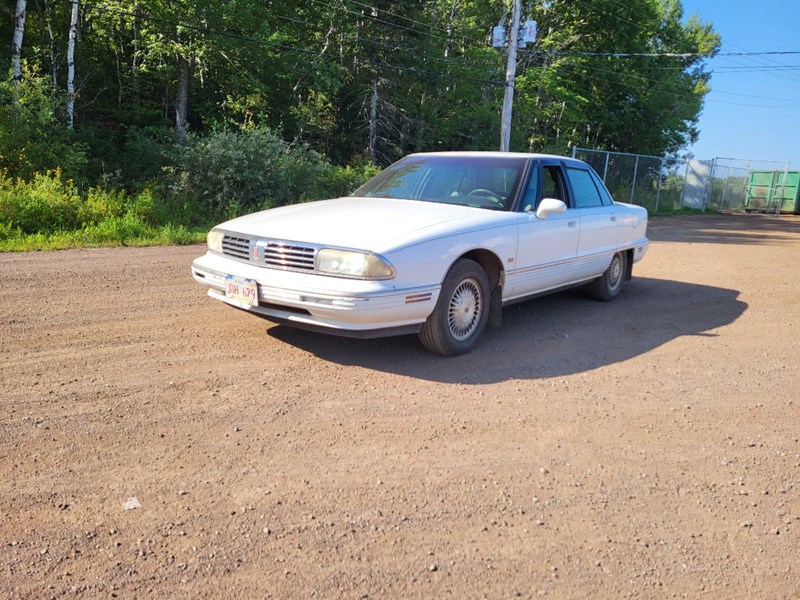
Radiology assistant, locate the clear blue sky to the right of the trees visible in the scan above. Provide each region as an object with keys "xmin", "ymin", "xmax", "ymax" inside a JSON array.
[{"xmin": 683, "ymin": 0, "xmax": 800, "ymax": 170}]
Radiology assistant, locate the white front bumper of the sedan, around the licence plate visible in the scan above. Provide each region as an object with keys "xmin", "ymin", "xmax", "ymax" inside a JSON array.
[{"xmin": 192, "ymin": 252, "xmax": 441, "ymax": 337}]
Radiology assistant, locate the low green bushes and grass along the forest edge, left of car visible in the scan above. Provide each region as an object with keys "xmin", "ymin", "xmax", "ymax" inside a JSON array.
[{"xmin": 0, "ymin": 123, "xmax": 377, "ymax": 251}]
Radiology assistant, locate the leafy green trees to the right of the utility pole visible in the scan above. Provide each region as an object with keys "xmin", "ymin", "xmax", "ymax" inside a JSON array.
[{"xmin": 517, "ymin": 0, "xmax": 720, "ymax": 155}]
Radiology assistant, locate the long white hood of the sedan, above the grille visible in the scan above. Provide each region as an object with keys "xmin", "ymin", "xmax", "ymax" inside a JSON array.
[{"xmin": 219, "ymin": 197, "xmax": 508, "ymax": 252}]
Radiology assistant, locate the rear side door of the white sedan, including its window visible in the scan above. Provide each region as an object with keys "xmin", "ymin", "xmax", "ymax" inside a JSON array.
[{"xmin": 564, "ymin": 164, "xmax": 619, "ymax": 278}]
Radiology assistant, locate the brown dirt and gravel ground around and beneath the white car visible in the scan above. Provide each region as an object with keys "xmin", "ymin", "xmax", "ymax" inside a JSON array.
[{"xmin": 0, "ymin": 216, "xmax": 800, "ymax": 600}]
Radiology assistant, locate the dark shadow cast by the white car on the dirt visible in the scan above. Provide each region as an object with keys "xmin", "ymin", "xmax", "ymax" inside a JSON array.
[{"xmin": 267, "ymin": 277, "xmax": 747, "ymax": 384}]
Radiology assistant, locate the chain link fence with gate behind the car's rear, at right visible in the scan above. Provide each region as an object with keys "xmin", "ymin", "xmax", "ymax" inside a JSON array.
[{"xmin": 572, "ymin": 147, "xmax": 800, "ymax": 214}]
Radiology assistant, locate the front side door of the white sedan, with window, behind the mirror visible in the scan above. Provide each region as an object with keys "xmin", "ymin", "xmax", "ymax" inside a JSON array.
[{"xmin": 504, "ymin": 159, "xmax": 580, "ymax": 300}]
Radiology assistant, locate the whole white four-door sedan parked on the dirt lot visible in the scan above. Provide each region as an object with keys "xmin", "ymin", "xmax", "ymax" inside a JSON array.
[{"xmin": 192, "ymin": 152, "xmax": 649, "ymax": 356}]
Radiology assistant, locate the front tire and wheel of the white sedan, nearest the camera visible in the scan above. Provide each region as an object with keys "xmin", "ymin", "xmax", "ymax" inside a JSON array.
[{"xmin": 419, "ymin": 258, "xmax": 489, "ymax": 356}]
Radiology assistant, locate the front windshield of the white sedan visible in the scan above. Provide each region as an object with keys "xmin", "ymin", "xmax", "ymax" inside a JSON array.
[{"xmin": 352, "ymin": 155, "xmax": 525, "ymax": 210}]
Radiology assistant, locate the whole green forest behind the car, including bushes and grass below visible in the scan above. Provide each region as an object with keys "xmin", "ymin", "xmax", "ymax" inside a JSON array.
[{"xmin": 0, "ymin": 0, "xmax": 720, "ymax": 247}]
